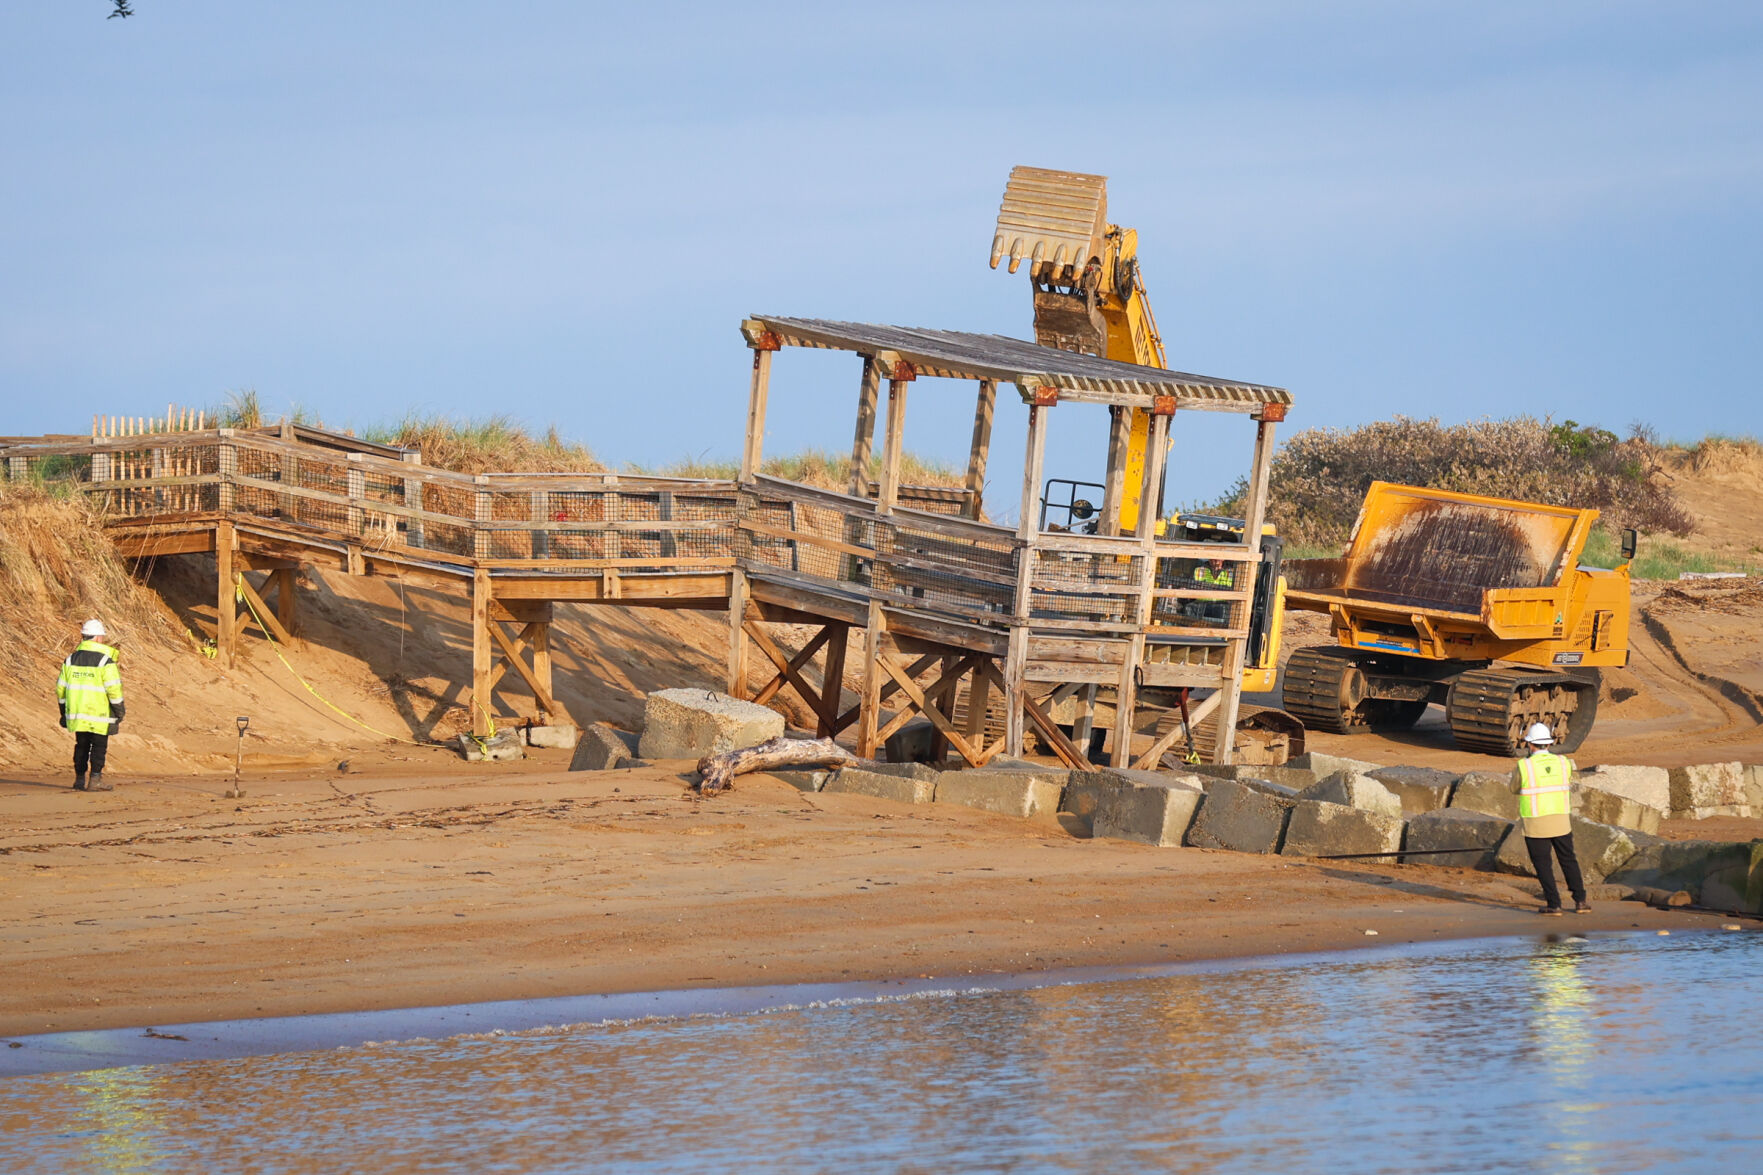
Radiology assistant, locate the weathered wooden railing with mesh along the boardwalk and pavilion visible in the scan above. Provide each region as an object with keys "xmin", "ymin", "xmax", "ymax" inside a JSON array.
[{"xmin": 0, "ymin": 429, "xmax": 1252, "ymax": 639}]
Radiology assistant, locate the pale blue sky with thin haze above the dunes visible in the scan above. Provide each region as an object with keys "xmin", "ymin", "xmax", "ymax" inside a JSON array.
[{"xmin": 0, "ymin": 0, "xmax": 1763, "ymax": 517}]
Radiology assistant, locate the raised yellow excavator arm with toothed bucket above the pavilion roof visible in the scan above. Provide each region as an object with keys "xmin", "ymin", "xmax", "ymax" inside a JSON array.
[{"xmin": 991, "ymin": 168, "xmax": 1169, "ymax": 533}]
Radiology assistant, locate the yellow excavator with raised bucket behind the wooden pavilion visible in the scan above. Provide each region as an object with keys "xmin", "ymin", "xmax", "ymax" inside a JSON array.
[{"xmin": 991, "ymin": 168, "xmax": 1303, "ymax": 760}]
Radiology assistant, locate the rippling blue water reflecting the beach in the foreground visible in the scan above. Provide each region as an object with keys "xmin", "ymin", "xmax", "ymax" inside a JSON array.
[{"xmin": 0, "ymin": 933, "xmax": 1763, "ymax": 1175}]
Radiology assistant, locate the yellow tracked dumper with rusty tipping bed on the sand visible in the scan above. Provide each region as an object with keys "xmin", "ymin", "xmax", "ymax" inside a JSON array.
[{"xmin": 1283, "ymin": 482, "xmax": 1634, "ymax": 755}]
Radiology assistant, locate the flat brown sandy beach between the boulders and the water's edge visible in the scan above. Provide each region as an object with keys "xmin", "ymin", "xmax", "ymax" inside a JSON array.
[{"xmin": 0, "ymin": 766, "xmax": 1722, "ymax": 1037}]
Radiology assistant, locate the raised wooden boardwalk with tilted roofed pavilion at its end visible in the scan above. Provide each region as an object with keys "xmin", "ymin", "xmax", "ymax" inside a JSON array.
[{"xmin": 0, "ymin": 319, "xmax": 1291, "ymax": 766}]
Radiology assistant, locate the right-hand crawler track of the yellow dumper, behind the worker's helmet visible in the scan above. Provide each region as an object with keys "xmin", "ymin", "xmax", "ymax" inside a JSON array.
[{"xmin": 1446, "ymin": 667, "xmax": 1599, "ymax": 755}]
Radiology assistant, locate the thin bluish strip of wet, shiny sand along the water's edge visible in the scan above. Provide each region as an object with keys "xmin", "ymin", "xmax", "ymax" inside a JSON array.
[{"xmin": 0, "ymin": 928, "xmax": 1692, "ymax": 1078}]
